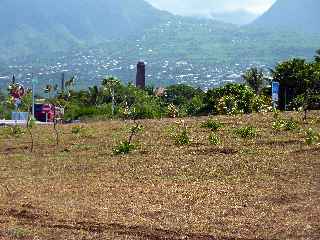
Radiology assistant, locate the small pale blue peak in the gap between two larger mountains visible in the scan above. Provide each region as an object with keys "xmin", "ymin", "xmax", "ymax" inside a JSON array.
[{"xmin": 209, "ymin": 10, "xmax": 258, "ymax": 25}]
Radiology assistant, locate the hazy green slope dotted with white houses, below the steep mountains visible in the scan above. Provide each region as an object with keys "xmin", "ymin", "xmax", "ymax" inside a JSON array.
[{"xmin": 0, "ymin": 16, "xmax": 320, "ymax": 89}]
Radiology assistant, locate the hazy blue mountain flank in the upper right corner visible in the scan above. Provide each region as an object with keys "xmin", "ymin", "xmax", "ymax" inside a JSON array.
[{"xmin": 253, "ymin": 0, "xmax": 320, "ymax": 34}]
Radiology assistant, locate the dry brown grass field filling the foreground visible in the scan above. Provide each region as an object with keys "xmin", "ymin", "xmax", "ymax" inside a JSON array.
[{"xmin": 0, "ymin": 112, "xmax": 320, "ymax": 240}]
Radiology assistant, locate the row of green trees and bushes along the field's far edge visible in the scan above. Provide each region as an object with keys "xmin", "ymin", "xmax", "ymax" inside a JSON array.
[{"xmin": 0, "ymin": 50, "xmax": 320, "ymax": 120}]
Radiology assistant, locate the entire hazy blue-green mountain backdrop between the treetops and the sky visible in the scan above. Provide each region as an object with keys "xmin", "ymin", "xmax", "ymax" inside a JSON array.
[{"xmin": 0, "ymin": 0, "xmax": 320, "ymax": 89}]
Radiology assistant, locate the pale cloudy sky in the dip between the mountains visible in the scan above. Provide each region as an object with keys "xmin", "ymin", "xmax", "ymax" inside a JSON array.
[{"xmin": 147, "ymin": 0, "xmax": 276, "ymax": 15}]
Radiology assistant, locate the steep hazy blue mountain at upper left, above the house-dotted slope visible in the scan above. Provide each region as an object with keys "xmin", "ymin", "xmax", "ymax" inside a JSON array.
[{"xmin": 0, "ymin": 0, "xmax": 169, "ymax": 59}]
